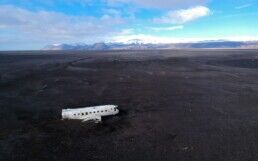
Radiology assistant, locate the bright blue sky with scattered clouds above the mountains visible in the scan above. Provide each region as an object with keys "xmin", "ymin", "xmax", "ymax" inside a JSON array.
[{"xmin": 0, "ymin": 0, "xmax": 258, "ymax": 50}]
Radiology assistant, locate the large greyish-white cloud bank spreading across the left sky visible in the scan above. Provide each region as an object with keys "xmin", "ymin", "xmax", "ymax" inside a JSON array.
[{"xmin": 0, "ymin": 5, "xmax": 124, "ymax": 42}]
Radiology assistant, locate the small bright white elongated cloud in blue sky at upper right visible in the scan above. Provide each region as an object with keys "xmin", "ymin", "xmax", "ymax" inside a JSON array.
[{"xmin": 154, "ymin": 6, "xmax": 211, "ymax": 24}]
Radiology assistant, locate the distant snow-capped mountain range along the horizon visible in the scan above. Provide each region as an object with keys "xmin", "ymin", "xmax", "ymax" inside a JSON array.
[{"xmin": 43, "ymin": 40, "xmax": 258, "ymax": 50}]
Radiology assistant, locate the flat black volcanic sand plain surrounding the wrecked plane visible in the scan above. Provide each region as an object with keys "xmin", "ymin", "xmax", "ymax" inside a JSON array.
[{"xmin": 0, "ymin": 50, "xmax": 258, "ymax": 161}]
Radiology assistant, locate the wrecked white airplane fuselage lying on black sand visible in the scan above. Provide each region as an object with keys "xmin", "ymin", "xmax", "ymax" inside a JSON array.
[{"xmin": 62, "ymin": 105, "xmax": 119, "ymax": 121}]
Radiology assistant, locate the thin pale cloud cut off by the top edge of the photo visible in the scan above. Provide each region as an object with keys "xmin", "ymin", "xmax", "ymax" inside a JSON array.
[{"xmin": 106, "ymin": 0, "xmax": 208, "ymax": 8}]
